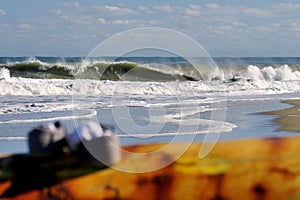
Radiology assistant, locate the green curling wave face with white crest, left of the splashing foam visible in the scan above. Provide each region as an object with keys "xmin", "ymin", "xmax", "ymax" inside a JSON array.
[{"xmin": 1, "ymin": 61, "xmax": 201, "ymax": 81}]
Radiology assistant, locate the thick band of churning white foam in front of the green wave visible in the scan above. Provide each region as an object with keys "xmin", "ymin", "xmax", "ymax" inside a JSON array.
[{"xmin": 0, "ymin": 65, "xmax": 300, "ymax": 96}]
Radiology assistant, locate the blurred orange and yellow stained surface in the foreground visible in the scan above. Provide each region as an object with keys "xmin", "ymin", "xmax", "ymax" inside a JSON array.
[{"xmin": 0, "ymin": 137, "xmax": 300, "ymax": 200}]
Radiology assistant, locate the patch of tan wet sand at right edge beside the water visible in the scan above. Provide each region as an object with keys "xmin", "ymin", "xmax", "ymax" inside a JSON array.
[{"xmin": 266, "ymin": 100, "xmax": 300, "ymax": 132}]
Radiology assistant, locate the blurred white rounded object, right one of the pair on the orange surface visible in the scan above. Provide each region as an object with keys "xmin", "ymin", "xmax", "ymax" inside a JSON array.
[{"xmin": 67, "ymin": 121, "xmax": 121, "ymax": 166}]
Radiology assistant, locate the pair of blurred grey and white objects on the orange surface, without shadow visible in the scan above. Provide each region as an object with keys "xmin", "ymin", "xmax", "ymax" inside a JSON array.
[{"xmin": 28, "ymin": 121, "xmax": 120, "ymax": 167}]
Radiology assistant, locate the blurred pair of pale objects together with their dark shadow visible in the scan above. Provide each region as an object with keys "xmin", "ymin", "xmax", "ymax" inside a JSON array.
[{"xmin": 0, "ymin": 121, "xmax": 121, "ymax": 198}]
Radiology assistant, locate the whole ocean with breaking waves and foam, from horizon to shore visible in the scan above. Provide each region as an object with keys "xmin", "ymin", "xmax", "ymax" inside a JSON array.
[{"xmin": 0, "ymin": 56, "xmax": 300, "ymax": 153}]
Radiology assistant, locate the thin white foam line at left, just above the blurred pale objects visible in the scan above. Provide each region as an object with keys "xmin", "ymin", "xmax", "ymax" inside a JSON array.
[{"xmin": 0, "ymin": 110, "xmax": 97, "ymax": 124}]
